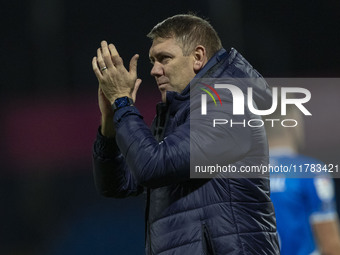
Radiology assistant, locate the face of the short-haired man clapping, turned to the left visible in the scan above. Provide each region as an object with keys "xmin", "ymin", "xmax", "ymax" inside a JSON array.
[{"xmin": 149, "ymin": 38, "xmax": 196, "ymax": 101}]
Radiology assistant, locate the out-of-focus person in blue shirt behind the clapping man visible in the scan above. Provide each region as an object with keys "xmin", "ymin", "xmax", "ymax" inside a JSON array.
[{"xmin": 266, "ymin": 102, "xmax": 340, "ymax": 255}]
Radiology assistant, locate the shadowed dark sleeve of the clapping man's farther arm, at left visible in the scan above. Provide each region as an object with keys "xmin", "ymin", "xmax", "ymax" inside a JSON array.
[{"xmin": 93, "ymin": 128, "xmax": 143, "ymax": 198}]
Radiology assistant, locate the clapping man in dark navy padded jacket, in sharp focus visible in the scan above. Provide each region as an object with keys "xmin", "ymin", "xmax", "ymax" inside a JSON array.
[{"xmin": 92, "ymin": 15, "xmax": 279, "ymax": 255}]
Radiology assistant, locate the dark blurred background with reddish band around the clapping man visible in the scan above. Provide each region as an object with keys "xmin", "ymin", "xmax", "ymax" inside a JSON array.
[{"xmin": 0, "ymin": 0, "xmax": 340, "ymax": 255}]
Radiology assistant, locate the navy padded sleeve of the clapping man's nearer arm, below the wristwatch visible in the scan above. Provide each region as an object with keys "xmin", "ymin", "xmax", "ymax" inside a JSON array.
[{"xmin": 114, "ymin": 98, "xmax": 250, "ymax": 188}]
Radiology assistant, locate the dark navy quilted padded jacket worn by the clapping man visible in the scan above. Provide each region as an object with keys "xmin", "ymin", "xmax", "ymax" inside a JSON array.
[{"xmin": 93, "ymin": 49, "xmax": 279, "ymax": 255}]
